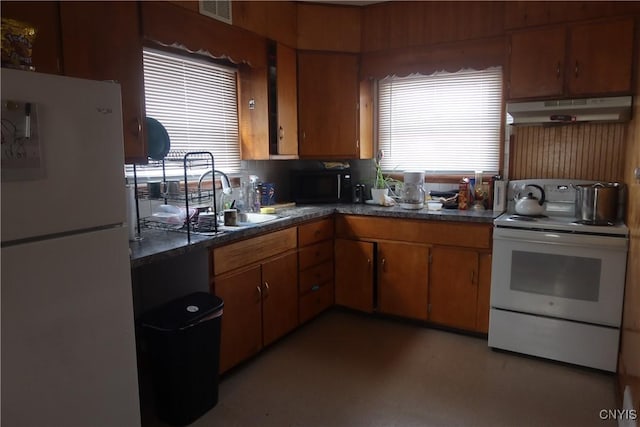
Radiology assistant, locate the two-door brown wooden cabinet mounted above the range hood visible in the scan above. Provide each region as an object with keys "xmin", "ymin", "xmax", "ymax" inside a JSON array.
[{"xmin": 507, "ymin": 18, "xmax": 634, "ymax": 100}]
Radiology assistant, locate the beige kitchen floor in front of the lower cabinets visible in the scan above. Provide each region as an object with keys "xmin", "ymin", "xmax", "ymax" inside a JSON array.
[{"xmin": 143, "ymin": 310, "xmax": 616, "ymax": 427}]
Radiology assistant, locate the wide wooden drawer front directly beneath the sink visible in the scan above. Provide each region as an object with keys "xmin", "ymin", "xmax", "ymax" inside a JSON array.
[{"xmin": 213, "ymin": 227, "xmax": 296, "ymax": 275}]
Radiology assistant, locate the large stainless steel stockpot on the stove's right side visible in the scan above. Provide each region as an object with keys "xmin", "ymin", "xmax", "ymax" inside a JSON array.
[{"xmin": 573, "ymin": 182, "xmax": 621, "ymax": 225}]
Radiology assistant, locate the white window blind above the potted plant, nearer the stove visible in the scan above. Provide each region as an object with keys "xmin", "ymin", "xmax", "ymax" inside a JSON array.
[{"xmin": 378, "ymin": 67, "xmax": 502, "ymax": 173}]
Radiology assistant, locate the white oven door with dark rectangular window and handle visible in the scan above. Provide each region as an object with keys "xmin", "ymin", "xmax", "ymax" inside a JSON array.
[{"xmin": 491, "ymin": 228, "xmax": 627, "ymax": 327}]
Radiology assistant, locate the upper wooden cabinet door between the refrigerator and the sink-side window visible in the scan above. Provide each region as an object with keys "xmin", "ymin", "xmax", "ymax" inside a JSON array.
[{"xmin": 59, "ymin": 1, "xmax": 147, "ymax": 163}]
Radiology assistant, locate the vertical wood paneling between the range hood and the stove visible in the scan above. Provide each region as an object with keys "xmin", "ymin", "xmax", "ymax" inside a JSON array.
[{"xmin": 509, "ymin": 123, "xmax": 627, "ymax": 181}]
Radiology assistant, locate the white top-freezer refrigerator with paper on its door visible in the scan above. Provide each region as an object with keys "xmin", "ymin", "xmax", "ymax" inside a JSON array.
[{"xmin": 0, "ymin": 69, "xmax": 140, "ymax": 427}]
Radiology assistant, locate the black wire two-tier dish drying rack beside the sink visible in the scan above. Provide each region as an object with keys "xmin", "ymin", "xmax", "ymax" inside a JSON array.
[{"xmin": 133, "ymin": 151, "xmax": 220, "ymax": 243}]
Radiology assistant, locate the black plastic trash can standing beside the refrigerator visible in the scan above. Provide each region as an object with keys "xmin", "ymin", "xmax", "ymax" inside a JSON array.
[{"xmin": 141, "ymin": 292, "xmax": 224, "ymax": 425}]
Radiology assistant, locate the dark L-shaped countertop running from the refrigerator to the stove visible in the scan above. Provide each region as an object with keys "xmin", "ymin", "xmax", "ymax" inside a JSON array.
[{"xmin": 129, "ymin": 204, "xmax": 499, "ymax": 268}]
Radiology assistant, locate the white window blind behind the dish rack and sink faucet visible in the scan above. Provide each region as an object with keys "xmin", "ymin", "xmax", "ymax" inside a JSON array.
[{"xmin": 143, "ymin": 49, "xmax": 240, "ymax": 173}]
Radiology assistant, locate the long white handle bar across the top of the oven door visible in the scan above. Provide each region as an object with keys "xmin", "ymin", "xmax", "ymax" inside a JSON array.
[{"xmin": 493, "ymin": 228, "xmax": 628, "ymax": 251}]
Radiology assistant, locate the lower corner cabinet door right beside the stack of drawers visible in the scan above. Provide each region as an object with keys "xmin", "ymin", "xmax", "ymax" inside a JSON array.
[{"xmin": 334, "ymin": 239, "xmax": 374, "ymax": 313}]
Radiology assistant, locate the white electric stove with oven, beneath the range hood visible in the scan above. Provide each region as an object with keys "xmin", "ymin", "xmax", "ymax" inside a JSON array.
[{"xmin": 489, "ymin": 179, "xmax": 629, "ymax": 372}]
